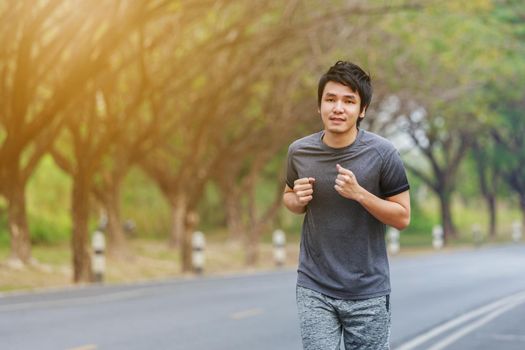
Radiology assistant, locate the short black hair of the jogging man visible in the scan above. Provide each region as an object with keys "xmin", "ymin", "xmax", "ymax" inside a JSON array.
[{"xmin": 317, "ymin": 61, "xmax": 373, "ymax": 126}]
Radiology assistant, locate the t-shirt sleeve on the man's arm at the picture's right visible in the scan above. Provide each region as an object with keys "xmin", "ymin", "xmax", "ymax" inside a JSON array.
[{"xmin": 380, "ymin": 149, "xmax": 410, "ymax": 197}]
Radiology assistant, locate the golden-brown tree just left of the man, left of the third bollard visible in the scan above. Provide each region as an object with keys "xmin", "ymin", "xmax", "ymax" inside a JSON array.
[{"xmin": 212, "ymin": 71, "xmax": 317, "ymax": 265}]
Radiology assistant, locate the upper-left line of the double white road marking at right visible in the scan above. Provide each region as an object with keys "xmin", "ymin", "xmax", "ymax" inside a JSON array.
[{"xmin": 396, "ymin": 292, "xmax": 525, "ymax": 350}]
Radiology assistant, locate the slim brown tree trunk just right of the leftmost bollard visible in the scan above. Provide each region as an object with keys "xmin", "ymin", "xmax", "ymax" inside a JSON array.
[{"xmin": 104, "ymin": 183, "xmax": 129, "ymax": 259}]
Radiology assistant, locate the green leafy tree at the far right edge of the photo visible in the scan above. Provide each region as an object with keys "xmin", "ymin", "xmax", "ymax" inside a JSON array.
[{"xmin": 473, "ymin": 0, "xmax": 525, "ymax": 237}]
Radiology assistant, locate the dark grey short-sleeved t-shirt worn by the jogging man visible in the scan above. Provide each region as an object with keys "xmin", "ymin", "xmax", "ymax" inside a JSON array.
[{"xmin": 286, "ymin": 129, "xmax": 409, "ymax": 300}]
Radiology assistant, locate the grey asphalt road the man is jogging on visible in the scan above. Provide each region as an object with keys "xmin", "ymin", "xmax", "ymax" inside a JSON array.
[{"xmin": 0, "ymin": 245, "xmax": 525, "ymax": 350}]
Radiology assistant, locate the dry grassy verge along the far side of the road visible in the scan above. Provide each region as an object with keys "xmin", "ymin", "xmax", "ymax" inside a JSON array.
[{"xmin": 0, "ymin": 236, "xmax": 510, "ymax": 293}]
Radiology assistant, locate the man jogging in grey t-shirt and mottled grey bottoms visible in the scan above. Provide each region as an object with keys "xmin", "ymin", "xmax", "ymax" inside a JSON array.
[{"xmin": 283, "ymin": 61, "xmax": 410, "ymax": 350}]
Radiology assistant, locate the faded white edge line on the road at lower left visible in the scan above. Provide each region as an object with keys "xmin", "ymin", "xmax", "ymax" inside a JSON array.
[{"xmin": 0, "ymin": 290, "xmax": 144, "ymax": 312}]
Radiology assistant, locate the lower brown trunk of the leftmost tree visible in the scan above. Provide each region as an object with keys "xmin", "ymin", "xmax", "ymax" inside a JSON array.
[{"xmin": 7, "ymin": 178, "xmax": 31, "ymax": 264}]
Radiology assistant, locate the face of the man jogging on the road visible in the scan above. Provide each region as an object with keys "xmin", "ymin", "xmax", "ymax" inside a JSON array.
[{"xmin": 319, "ymin": 81, "xmax": 365, "ymax": 134}]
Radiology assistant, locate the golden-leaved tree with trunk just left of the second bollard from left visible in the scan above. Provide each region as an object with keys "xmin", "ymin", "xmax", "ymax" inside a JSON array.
[{"xmin": 135, "ymin": 2, "xmax": 284, "ymax": 271}]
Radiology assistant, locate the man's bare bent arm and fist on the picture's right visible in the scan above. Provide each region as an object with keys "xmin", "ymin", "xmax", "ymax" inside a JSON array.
[{"xmin": 335, "ymin": 165, "xmax": 410, "ymax": 230}]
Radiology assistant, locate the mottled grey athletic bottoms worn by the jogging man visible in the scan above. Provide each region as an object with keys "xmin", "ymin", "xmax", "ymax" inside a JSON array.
[{"xmin": 297, "ymin": 286, "xmax": 390, "ymax": 350}]
